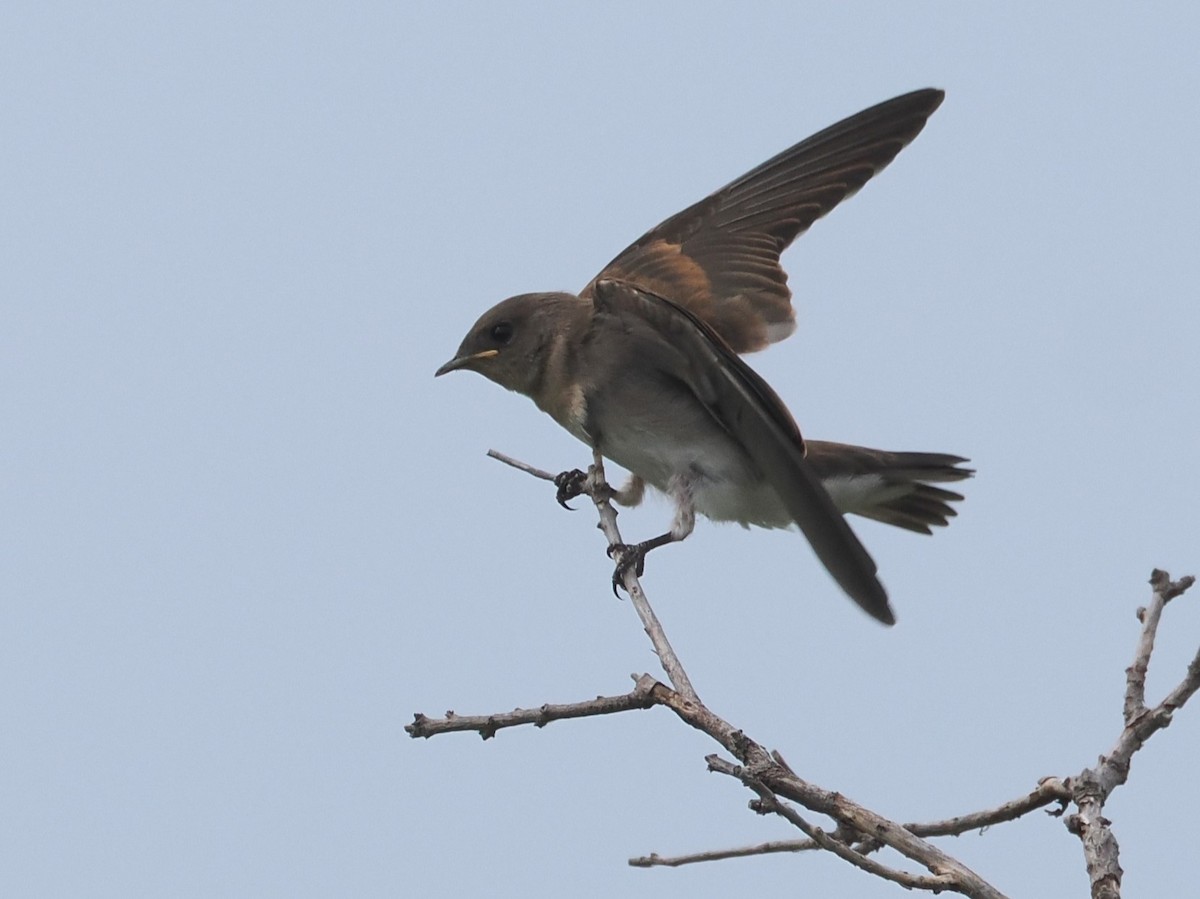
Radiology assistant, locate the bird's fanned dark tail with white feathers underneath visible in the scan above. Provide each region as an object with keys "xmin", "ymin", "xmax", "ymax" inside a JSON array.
[{"xmin": 805, "ymin": 440, "xmax": 974, "ymax": 534}]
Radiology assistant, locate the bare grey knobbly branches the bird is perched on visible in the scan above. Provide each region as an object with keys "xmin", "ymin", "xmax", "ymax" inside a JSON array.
[{"xmin": 404, "ymin": 450, "xmax": 1200, "ymax": 899}]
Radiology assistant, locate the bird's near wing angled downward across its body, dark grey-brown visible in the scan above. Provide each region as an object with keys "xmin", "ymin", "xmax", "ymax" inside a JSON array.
[{"xmin": 593, "ymin": 280, "xmax": 895, "ymax": 624}]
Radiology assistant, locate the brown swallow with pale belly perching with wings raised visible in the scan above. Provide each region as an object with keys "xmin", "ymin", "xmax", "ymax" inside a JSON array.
[{"xmin": 436, "ymin": 88, "xmax": 974, "ymax": 625}]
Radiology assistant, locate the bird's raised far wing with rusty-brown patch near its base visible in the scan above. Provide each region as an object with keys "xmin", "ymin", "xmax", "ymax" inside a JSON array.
[{"xmin": 581, "ymin": 89, "xmax": 944, "ymax": 353}]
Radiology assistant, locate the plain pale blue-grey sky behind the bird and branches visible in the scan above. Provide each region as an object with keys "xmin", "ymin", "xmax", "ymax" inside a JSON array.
[{"xmin": 0, "ymin": 2, "xmax": 1200, "ymax": 897}]
